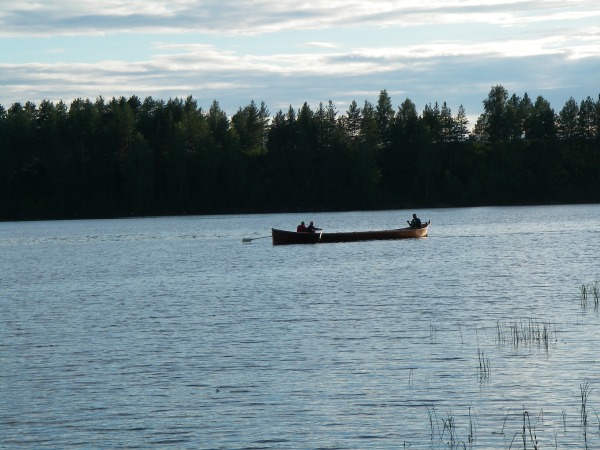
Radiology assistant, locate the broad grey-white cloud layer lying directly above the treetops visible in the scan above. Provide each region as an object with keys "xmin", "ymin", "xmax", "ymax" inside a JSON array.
[{"xmin": 0, "ymin": 34, "xmax": 600, "ymax": 115}]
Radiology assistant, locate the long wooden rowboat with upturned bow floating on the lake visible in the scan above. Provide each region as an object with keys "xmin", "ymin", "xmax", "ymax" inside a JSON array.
[{"xmin": 271, "ymin": 221, "xmax": 431, "ymax": 245}]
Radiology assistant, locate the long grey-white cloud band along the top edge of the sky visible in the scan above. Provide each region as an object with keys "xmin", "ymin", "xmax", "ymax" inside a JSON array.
[{"xmin": 0, "ymin": 0, "xmax": 600, "ymax": 36}]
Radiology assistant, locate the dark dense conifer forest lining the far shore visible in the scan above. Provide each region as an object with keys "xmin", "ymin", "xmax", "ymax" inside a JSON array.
[{"xmin": 0, "ymin": 86, "xmax": 600, "ymax": 220}]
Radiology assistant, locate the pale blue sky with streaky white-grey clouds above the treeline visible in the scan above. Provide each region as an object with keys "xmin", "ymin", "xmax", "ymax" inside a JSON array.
[{"xmin": 0, "ymin": 0, "xmax": 600, "ymax": 126}]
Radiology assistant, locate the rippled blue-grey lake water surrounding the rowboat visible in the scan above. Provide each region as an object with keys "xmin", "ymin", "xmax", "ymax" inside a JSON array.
[{"xmin": 0, "ymin": 205, "xmax": 600, "ymax": 449}]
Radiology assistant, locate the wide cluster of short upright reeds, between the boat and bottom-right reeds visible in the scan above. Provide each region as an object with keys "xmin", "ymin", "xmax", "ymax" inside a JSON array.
[{"xmin": 496, "ymin": 318, "xmax": 557, "ymax": 350}]
